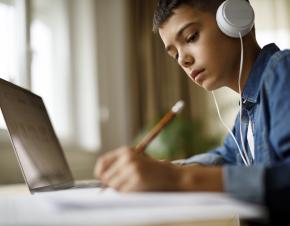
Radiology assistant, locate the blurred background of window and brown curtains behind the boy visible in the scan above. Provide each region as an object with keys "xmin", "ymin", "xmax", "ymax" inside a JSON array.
[{"xmin": 0, "ymin": 0, "xmax": 290, "ymax": 184}]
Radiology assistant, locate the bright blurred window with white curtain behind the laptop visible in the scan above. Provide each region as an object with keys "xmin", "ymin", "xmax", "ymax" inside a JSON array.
[{"xmin": 0, "ymin": 0, "xmax": 100, "ymax": 151}]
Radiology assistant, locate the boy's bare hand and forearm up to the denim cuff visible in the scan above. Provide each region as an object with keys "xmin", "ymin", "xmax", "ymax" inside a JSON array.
[{"xmin": 95, "ymin": 147, "xmax": 223, "ymax": 192}]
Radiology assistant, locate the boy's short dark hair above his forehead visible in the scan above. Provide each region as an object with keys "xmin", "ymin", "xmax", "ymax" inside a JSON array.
[{"xmin": 153, "ymin": 0, "xmax": 248, "ymax": 33}]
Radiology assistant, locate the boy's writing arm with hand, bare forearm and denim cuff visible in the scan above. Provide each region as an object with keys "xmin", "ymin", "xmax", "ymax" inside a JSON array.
[{"xmin": 95, "ymin": 148, "xmax": 263, "ymax": 204}]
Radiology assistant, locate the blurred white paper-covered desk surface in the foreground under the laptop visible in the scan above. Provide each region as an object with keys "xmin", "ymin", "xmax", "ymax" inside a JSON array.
[{"xmin": 0, "ymin": 184, "xmax": 266, "ymax": 226}]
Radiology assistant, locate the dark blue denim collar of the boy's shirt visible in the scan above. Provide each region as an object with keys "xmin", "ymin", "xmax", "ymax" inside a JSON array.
[{"xmin": 242, "ymin": 43, "xmax": 279, "ymax": 103}]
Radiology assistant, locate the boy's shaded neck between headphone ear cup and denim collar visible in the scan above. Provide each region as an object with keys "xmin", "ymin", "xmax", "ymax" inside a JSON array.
[{"xmin": 229, "ymin": 35, "xmax": 261, "ymax": 93}]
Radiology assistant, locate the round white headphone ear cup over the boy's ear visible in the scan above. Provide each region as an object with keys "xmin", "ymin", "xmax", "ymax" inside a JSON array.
[{"xmin": 216, "ymin": 0, "xmax": 255, "ymax": 38}]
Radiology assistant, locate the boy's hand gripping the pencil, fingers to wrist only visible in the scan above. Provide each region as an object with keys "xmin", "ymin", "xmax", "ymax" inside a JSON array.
[{"xmin": 95, "ymin": 147, "xmax": 181, "ymax": 191}]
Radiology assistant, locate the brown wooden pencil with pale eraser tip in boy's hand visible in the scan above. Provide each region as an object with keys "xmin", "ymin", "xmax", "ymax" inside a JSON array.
[{"xmin": 135, "ymin": 100, "xmax": 184, "ymax": 152}]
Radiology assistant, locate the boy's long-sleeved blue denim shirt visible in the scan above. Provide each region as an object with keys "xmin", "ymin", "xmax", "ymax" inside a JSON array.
[{"xmin": 185, "ymin": 44, "xmax": 290, "ymax": 204}]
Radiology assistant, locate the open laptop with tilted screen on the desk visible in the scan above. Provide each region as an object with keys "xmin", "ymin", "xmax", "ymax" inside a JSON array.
[{"xmin": 0, "ymin": 79, "xmax": 103, "ymax": 193}]
